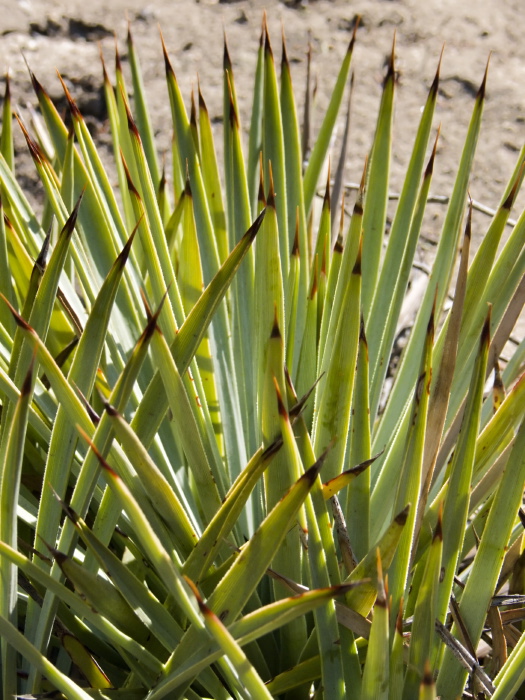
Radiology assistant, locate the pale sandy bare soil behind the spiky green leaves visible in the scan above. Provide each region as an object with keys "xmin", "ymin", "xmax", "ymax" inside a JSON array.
[{"xmin": 0, "ymin": 0, "xmax": 525, "ymax": 344}]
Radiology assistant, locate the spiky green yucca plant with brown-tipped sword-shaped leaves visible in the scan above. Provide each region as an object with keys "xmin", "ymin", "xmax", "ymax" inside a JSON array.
[{"xmin": 0, "ymin": 12, "xmax": 525, "ymax": 700}]
